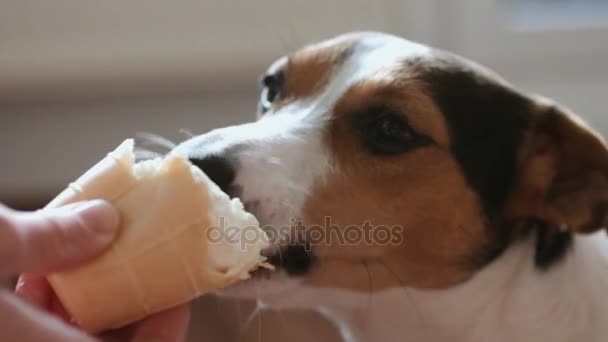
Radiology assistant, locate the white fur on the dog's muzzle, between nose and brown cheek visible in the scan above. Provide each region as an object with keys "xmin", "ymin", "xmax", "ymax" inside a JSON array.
[{"xmin": 177, "ymin": 113, "xmax": 328, "ymax": 238}]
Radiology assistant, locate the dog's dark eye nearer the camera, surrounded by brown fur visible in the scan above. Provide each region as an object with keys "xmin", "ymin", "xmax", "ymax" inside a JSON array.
[{"xmin": 356, "ymin": 108, "xmax": 430, "ymax": 155}]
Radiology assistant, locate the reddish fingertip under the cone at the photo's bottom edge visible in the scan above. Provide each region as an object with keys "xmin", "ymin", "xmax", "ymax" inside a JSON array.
[{"xmin": 132, "ymin": 305, "xmax": 190, "ymax": 342}]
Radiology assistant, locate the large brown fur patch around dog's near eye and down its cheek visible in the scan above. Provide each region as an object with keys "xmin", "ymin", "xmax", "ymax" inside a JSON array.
[{"xmin": 296, "ymin": 81, "xmax": 486, "ymax": 291}]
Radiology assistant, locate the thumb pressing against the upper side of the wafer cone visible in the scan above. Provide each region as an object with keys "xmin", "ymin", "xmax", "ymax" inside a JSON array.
[{"xmin": 0, "ymin": 200, "xmax": 119, "ymax": 275}]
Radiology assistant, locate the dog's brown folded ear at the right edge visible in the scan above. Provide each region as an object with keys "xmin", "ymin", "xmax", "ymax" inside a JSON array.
[{"xmin": 511, "ymin": 100, "xmax": 608, "ymax": 233}]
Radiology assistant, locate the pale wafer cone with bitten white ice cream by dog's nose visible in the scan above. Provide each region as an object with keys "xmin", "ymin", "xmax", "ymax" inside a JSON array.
[{"xmin": 47, "ymin": 140, "xmax": 267, "ymax": 332}]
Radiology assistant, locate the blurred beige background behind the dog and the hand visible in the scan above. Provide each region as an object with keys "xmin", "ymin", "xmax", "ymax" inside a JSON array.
[{"xmin": 0, "ymin": 0, "xmax": 608, "ymax": 341}]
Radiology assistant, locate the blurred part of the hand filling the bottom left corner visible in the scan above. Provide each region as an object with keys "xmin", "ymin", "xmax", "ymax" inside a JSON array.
[{"xmin": 0, "ymin": 291, "xmax": 94, "ymax": 342}]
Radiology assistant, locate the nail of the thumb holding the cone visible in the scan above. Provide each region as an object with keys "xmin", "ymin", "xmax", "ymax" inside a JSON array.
[{"xmin": 72, "ymin": 200, "xmax": 120, "ymax": 237}]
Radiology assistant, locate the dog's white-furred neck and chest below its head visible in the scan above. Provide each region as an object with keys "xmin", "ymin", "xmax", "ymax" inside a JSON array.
[{"xmin": 292, "ymin": 232, "xmax": 608, "ymax": 342}]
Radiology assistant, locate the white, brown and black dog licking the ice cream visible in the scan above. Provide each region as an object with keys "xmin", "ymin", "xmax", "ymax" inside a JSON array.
[{"xmin": 177, "ymin": 32, "xmax": 608, "ymax": 342}]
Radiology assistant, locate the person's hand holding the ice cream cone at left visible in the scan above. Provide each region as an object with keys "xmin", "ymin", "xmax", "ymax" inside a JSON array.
[{"xmin": 0, "ymin": 200, "xmax": 189, "ymax": 341}]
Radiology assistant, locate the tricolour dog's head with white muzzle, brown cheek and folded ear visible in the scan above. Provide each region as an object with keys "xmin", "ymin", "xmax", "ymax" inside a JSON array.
[{"xmin": 173, "ymin": 33, "xmax": 608, "ymax": 291}]
